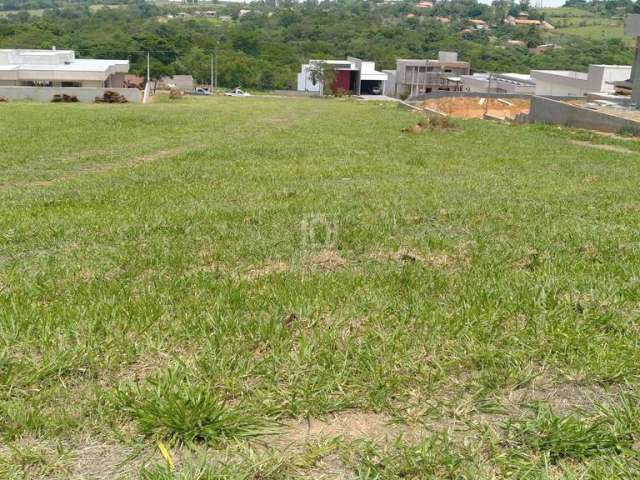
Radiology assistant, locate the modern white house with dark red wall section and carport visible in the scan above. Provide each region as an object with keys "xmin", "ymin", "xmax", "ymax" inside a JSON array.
[{"xmin": 298, "ymin": 57, "xmax": 387, "ymax": 95}]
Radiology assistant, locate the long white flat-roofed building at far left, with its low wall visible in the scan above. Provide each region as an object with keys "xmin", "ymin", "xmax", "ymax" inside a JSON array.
[{"xmin": 0, "ymin": 48, "xmax": 140, "ymax": 102}]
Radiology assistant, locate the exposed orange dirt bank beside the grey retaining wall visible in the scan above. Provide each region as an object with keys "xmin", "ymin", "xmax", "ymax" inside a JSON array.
[{"xmin": 422, "ymin": 97, "xmax": 530, "ymax": 120}]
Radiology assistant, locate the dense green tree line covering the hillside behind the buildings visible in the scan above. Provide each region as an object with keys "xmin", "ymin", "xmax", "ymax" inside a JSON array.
[{"xmin": 0, "ymin": 0, "xmax": 633, "ymax": 89}]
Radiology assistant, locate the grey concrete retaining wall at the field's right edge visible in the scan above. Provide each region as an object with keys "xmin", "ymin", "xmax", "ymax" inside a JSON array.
[{"xmin": 529, "ymin": 97, "xmax": 640, "ymax": 135}]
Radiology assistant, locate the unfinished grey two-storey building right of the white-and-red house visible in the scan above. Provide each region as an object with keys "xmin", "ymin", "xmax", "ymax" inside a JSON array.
[{"xmin": 384, "ymin": 52, "xmax": 471, "ymax": 97}]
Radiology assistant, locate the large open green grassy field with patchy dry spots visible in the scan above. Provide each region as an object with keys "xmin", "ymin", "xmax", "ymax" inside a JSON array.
[{"xmin": 0, "ymin": 97, "xmax": 640, "ymax": 480}]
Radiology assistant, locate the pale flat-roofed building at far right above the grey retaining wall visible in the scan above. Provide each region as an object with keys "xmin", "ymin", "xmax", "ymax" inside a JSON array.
[{"xmin": 531, "ymin": 65, "xmax": 631, "ymax": 97}]
